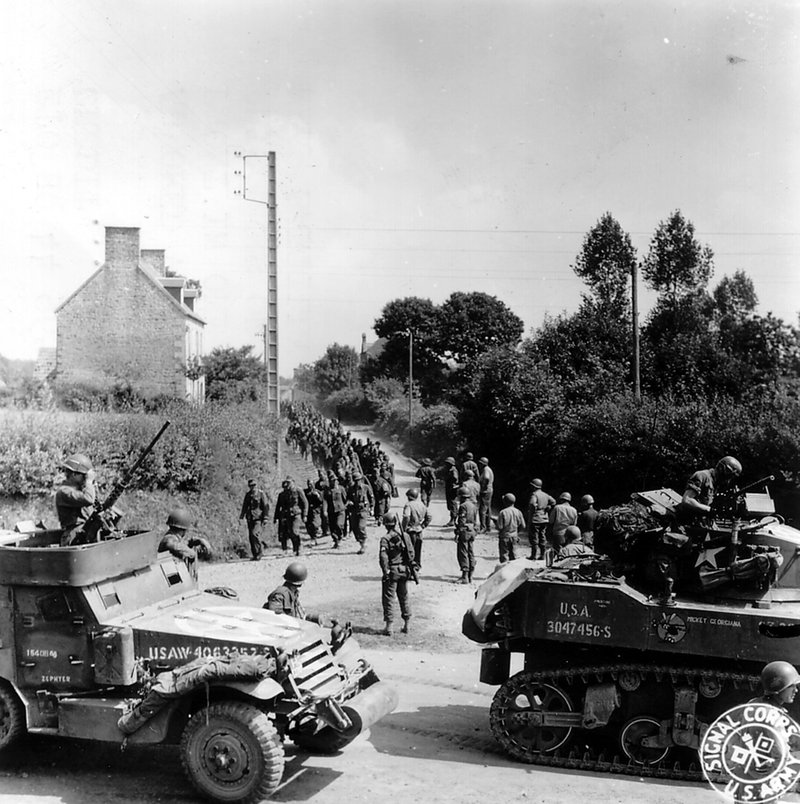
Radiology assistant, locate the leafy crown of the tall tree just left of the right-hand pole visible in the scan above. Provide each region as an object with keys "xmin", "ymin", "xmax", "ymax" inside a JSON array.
[{"xmin": 572, "ymin": 212, "xmax": 636, "ymax": 310}]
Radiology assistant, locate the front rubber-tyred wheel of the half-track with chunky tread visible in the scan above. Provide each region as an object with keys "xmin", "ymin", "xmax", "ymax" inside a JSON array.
[{"xmin": 181, "ymin": 701, "xmax": 284, "ymax": 804}]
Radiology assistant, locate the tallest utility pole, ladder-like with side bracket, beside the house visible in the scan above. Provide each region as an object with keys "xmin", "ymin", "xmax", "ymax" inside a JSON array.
[{"xmin": 234, "ymin": 151, "xmax": 281, "ymax": 475}]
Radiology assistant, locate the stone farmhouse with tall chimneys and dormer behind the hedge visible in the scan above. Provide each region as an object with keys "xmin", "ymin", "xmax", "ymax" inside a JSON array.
[{"xmin": 49, "ymin": 226, "xmax": 205, "ymax": 403}]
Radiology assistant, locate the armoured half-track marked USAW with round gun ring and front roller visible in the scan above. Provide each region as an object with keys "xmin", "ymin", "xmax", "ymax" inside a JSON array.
[{"xmin": 0, "ymin": 528, "xmax": 397, "ymax": 802}]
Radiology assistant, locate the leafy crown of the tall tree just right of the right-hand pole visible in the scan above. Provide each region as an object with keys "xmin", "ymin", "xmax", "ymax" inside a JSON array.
[{"xmin": 642, "ymin": 210, "xmax": 714, "ymax": 303}]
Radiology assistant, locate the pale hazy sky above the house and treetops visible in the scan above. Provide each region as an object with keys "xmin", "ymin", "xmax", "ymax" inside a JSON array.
[{"xmin": 0, "ymin": 0, "xmax": 800, "ymax": 375}]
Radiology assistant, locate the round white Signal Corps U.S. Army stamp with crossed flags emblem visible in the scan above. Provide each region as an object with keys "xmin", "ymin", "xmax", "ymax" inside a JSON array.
[{"xmin": 700, "ymin": 703, "xmax": 800, "ymax": 804}]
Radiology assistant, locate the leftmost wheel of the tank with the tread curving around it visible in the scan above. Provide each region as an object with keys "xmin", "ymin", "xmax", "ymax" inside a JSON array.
[{"xmin": 489, "ymin": 671, "xmax": 574, "ymax": 762}]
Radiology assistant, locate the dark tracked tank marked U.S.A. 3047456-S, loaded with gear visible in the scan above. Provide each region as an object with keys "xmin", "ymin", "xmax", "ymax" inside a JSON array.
[{"xmin": 462, "ymin": 478, "xmax": 800, "ymax": 779}]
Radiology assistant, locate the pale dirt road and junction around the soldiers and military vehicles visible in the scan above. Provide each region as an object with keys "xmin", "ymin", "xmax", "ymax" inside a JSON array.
[{"xmin": 0, "ymin": 424, "xmax": 756, "ymax": 804}]
